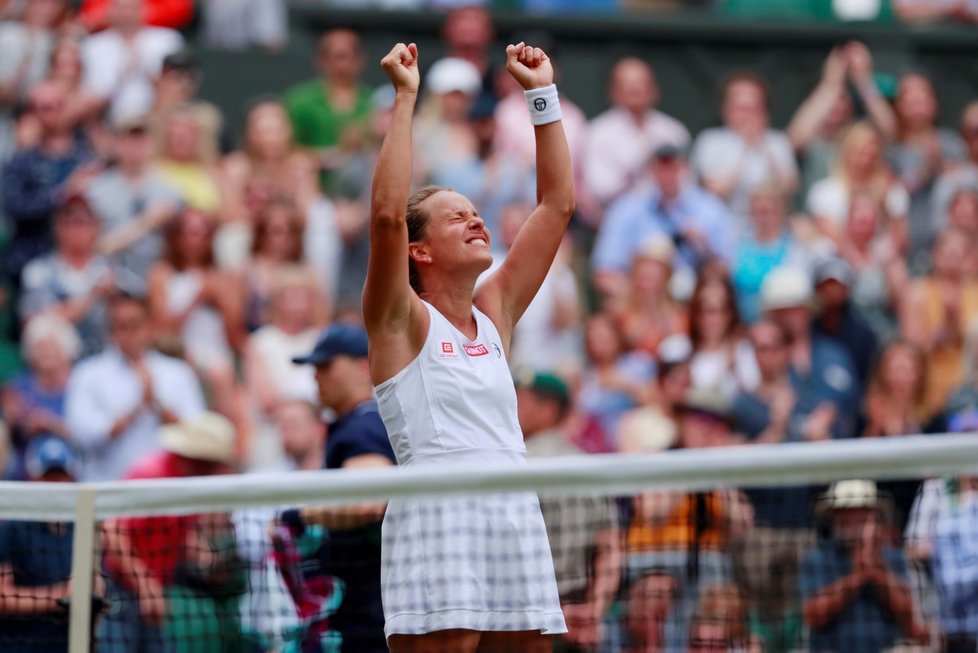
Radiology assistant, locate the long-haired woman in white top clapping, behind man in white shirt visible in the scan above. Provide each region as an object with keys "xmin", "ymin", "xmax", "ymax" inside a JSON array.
[{"xmin": 147, "ymin": 209, "xmax": 244, "ymax": 419}]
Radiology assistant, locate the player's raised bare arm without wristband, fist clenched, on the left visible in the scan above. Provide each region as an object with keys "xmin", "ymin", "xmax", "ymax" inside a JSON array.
[{"xmin": 363, "ymin": 43, "xmax": 421, "ymax": 338}]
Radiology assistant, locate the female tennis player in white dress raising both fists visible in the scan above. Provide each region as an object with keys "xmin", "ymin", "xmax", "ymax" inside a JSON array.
[{"xmin": 363, "ymin": 43, "xmax": 574, "ymax": 653}]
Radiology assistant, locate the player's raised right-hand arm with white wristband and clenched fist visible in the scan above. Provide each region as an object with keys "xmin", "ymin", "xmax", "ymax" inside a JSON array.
[{"xmin": 475, "ymin": 43, "xmax": 574, "ymax": 339}]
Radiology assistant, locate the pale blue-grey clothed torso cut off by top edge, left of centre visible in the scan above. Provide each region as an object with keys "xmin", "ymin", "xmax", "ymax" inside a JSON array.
[{"xmin": 204, "ymin": 0, "xmax": 289, "ymax": 52}]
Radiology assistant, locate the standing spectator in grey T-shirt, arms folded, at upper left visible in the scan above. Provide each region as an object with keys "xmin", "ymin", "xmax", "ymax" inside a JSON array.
[{"xmin": 85, "ymin": 118, "xmax": 183, "ymax": 295}]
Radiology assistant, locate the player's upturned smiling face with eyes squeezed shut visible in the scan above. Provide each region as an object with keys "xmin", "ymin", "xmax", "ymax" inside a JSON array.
[{"xmin": 409, "ymin": 191, "xmax": 492, "ymax": 274}]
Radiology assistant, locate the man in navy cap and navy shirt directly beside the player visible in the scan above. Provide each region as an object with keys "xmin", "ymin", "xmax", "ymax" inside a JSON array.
[{"xmin": 282, "ymin": 323, "xmax": 396, "ymax": 653}]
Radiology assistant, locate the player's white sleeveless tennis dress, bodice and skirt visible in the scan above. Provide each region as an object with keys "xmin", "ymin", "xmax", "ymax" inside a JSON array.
[{"xmin": 375, "ymin": 302, "xmax": 567, "ymax": 637}]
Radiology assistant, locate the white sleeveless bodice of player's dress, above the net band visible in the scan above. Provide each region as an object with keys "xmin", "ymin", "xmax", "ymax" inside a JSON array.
[{"xmin": 375, "ymin": 302, "xmax": 526, "ymax": 465}]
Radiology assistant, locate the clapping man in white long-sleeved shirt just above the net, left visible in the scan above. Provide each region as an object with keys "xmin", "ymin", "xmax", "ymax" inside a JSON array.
[{"xmin": 65, "ymin": 294, "xmax": 204, "ymax": 481}]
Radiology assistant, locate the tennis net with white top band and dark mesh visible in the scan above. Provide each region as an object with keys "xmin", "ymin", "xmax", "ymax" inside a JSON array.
[{"xmin": 0, "ymin": 436, "xmax": 978, "ymax": 653}]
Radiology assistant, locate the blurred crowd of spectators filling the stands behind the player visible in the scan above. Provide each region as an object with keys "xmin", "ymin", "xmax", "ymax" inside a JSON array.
[{"xmin": 0, "ymin": 0, "xmax": 978, "ymax": 653}]
